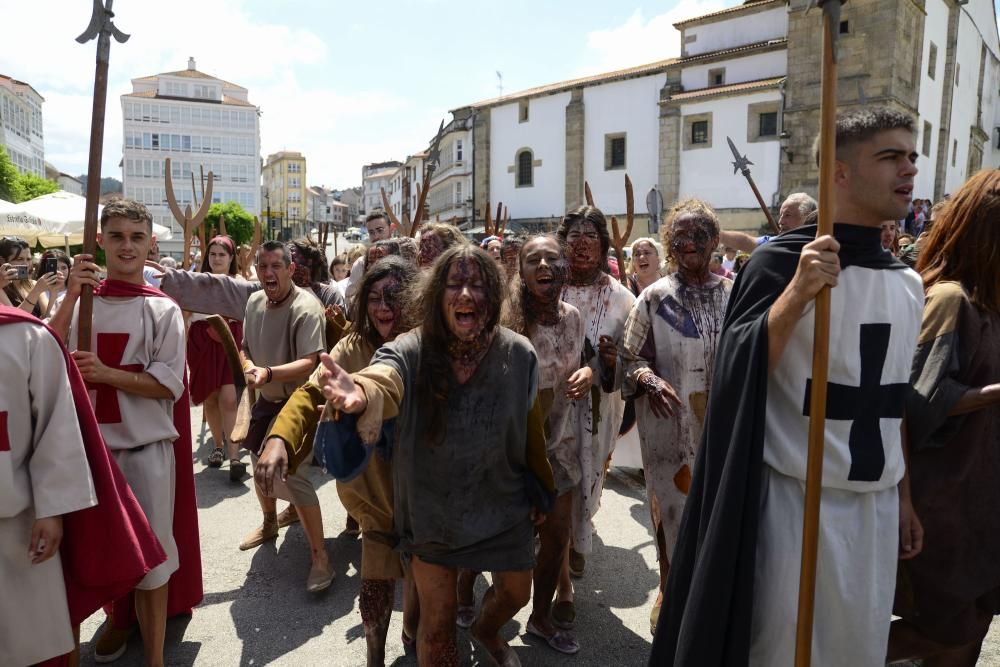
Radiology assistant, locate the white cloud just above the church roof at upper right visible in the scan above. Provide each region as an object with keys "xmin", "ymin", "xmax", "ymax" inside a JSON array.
[{"xmin": 580, "ymin": 0, "xmax": 741, "ymax": 76}]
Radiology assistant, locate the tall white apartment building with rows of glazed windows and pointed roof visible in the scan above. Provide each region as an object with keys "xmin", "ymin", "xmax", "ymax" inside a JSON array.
[{"xmin": 121, "ymin": 58, "xmax": 261, "ymax": 254}]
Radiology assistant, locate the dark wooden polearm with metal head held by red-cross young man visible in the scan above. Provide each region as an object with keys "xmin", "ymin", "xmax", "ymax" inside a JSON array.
[{"xmin": 76, "ymin": 0, "xmax": 129, "ymax": 352}]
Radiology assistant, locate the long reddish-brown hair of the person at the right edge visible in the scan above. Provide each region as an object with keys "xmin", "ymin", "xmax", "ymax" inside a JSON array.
[{"xmin": 917, "ymin": 169, "xmax": 1000, "ymax": 313}]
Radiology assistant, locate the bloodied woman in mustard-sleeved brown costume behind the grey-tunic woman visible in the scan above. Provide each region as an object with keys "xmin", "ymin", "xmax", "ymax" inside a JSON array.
[{"xmin": 258, "ymin": 254, "xmax": 419, "ymax": 667}]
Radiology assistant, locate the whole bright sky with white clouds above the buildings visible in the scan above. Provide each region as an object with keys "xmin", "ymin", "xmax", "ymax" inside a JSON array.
[{"xmin": 0, "ymin": 0, "xmax": 740, "ymax": 187}]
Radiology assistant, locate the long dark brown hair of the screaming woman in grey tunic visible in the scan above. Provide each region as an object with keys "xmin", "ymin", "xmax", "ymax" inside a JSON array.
[{"xmin": 409, "ymin": 243, "xmax": 507, "ymax": 443}]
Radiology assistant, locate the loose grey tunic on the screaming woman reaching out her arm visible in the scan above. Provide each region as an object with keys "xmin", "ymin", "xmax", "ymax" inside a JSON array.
[{"xmin": 372, "ymin": 328, "xmax": 538, "ymax": 572}]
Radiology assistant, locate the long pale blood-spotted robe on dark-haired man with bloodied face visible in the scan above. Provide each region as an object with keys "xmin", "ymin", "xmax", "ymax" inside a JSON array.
[{"xmin": 562, "ymin": 273, "xmax": 635, "ymax": 553}]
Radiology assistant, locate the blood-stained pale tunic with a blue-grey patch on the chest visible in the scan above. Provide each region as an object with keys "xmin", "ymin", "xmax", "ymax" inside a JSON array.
[{"xmin": 622, "ymin": 273, "xmax": 733, "ymax": 559}]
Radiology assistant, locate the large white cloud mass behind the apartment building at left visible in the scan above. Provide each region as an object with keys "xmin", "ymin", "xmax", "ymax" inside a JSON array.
[{"xmin": 0, "ymin": 0, "xmax": 422, "ymax": 193}]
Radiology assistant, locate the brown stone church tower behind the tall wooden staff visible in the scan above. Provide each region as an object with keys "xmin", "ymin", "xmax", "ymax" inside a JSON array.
[{"xmin": 779, "ymin": 0, "xmax": 925, "ymax": 195}]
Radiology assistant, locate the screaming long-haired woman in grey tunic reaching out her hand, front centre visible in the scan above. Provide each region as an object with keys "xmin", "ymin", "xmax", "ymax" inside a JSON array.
[{"xmin": 320, "ymin": 243, "xmax": 555, "ymax": 667}]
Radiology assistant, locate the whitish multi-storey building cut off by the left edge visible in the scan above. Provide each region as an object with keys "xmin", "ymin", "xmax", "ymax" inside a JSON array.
[{"xmin": 0, "ymin": 74, "xmax": 45, "ymax": 178}]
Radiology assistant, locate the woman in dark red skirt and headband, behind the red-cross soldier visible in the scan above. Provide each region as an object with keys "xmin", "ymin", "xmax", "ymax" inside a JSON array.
[{"xmin": 187, "ymin": 235, "xmax": 243, "ymax": 468}]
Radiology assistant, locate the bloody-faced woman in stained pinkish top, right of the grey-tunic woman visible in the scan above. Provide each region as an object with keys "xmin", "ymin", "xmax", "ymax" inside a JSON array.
[{"xmin": 504, "ymin": 236, "xmax": 593, "ymax": 654}]
